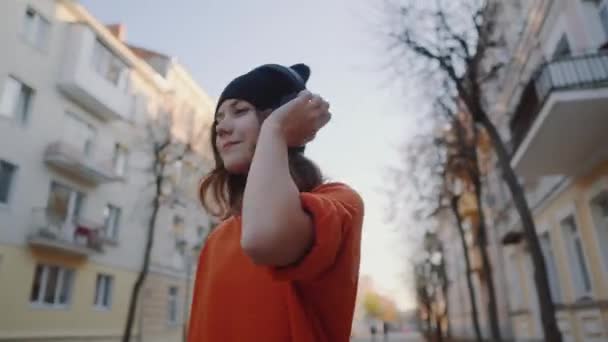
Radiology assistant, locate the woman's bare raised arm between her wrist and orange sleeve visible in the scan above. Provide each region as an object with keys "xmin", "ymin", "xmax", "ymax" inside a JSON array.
[{"xmin": 241, "ymin": 120, "xmax": 313, "ymax": 266}]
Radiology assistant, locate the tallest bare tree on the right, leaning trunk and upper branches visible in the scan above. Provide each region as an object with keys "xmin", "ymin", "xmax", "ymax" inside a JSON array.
[{"xmin": 388, "ymin": 0, "xmax": 561, "ymax": 342}]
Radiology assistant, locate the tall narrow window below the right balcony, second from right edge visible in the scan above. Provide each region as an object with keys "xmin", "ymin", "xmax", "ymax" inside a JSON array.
[{"xmin": 560, "ymin": 215, "xmax": 591, "ymax": 299}]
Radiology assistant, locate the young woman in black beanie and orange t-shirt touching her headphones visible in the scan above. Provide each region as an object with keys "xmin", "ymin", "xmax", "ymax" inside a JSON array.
[{"xmin": 188, "ymin": 64, "xmax": 363, "ymax": 342}]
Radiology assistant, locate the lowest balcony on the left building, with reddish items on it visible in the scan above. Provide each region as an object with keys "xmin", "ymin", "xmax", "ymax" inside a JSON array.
[{"xmin": 27, "ymin": 208, "xmax": 103, "ymax": 257}]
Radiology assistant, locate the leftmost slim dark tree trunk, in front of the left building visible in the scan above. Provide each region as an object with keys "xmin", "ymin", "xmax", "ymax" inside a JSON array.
[{"xmin": 122, "ymin": 172, "xmax": 163, "ymax": 342}]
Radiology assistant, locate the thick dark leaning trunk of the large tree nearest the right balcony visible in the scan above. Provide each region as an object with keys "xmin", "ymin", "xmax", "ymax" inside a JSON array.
[{"xmin": 475, "ymin": 111, "xmax": 562, "ymax": 342}]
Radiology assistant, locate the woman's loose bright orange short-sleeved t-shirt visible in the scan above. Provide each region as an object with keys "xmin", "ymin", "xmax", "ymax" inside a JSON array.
[{"xmin": 188, "ymin": 183, "xmax": 363, "ymax": 342}]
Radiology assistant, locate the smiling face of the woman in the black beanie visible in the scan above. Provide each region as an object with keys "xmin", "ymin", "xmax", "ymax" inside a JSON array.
[{"xmin": 215, "ymin": 99, "xmax": 260, "ymax": 174}]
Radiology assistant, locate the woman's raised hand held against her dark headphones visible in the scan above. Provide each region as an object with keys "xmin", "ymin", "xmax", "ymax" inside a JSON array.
[{"xmin": 263, "ymin": 90, "xmax": 331, "ymax": 147}]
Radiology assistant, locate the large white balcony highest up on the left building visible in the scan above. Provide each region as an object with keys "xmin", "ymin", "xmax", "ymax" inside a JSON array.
[{"xmin": 59, "ymin": 23, "xmax": 131, "ymax": 121}]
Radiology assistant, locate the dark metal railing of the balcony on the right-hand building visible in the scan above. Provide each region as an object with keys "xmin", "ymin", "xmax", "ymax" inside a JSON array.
[{"xmin": 510, "ymin": 52, "xmax": 608, "ymax": 151}]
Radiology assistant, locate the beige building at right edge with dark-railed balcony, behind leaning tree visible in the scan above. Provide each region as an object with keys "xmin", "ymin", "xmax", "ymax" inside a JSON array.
[{"xmin": 446, "ymin": 0, "xmax": 608, "ymax": 342}]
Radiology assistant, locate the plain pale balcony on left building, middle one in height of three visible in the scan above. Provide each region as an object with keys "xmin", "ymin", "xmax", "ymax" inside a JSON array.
[{"xmin": 44, "ymin": 141, "xmax": 122, "ymax": 185}]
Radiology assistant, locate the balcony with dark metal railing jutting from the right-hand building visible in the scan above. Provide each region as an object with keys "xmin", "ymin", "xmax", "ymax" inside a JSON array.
[{"xmin": 510, "ymin": 52, "xmax": 608, "ymax": 178}]
